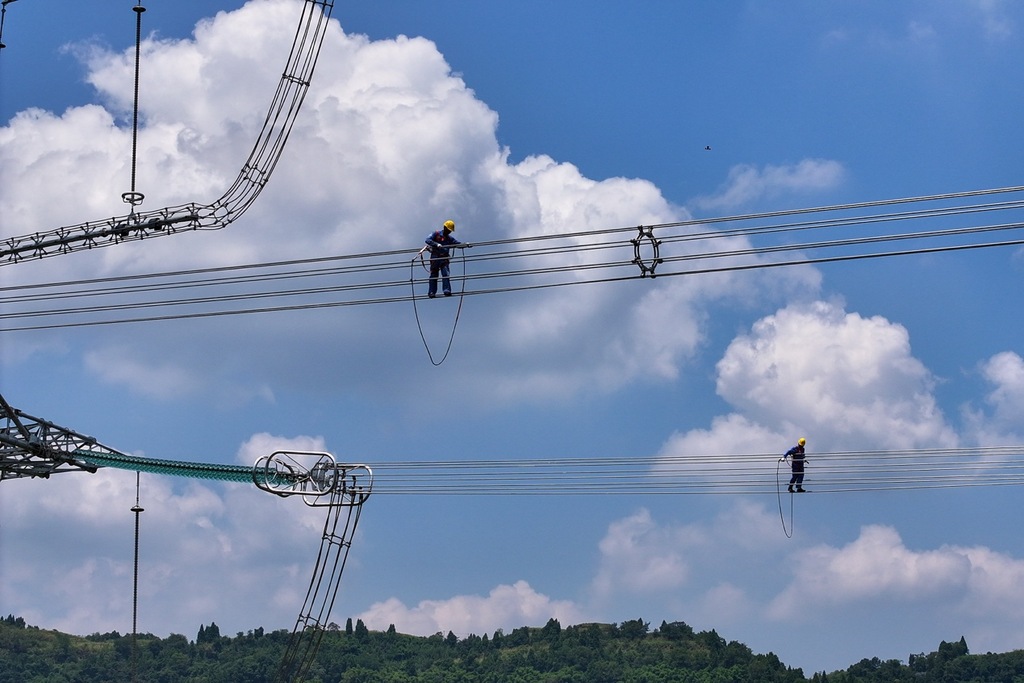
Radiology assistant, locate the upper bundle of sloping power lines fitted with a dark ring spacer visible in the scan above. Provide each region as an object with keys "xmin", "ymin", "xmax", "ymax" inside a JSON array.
[{"xmin": 0, "ymin": 187, "xmax": 1024, "ymax": 331}]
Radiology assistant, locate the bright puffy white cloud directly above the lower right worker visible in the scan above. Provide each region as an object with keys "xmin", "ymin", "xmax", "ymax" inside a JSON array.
[{"xmin": 718, "ymin": 301, "xmax": 956, "ymax": 450}]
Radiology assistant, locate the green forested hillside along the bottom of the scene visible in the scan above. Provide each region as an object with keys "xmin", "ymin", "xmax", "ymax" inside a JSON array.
[{"xmin": 0, "ymin": 616, "xmax": 1024, "ymax": 683}]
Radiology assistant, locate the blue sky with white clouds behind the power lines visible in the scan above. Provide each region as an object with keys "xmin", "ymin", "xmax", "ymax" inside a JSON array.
[{"xmin": 0, "ymin": 0, "xmax": 1024, "ymax": 674}]
